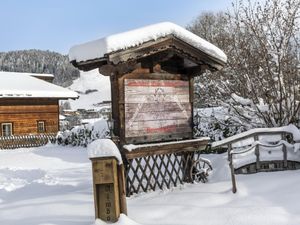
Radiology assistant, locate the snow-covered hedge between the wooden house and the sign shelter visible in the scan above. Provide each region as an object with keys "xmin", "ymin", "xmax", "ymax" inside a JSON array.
[{"xmin": 57, "ymin": 119, "xmax": 109, "ymax": 147}]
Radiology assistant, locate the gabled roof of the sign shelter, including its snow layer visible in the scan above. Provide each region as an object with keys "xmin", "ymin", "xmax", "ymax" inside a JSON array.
[{"xmin": 69, "ymin": 22, "xmax": 227, "ymax": 70}]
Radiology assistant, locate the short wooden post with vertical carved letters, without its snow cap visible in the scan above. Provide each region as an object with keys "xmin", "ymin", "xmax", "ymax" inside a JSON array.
[{"xmin": 91, "ymin": 157, "xmax": 127, "ymax": 222}]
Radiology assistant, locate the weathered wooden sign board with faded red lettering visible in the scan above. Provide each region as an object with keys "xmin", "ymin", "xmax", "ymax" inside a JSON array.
[{"xmin": 124, "ymin": 79, "xmax": 192, "ymax": 142}]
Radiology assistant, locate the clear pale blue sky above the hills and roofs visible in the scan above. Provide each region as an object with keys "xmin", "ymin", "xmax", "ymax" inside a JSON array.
[{"xmin": 0, "ymin": 0, "xmax": 231, "ymax": 54}]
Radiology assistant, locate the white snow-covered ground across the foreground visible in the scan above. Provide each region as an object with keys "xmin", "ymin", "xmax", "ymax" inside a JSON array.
[{"xmin": 0, "ymin": 145, "xmax": 300, "ymax": 225}]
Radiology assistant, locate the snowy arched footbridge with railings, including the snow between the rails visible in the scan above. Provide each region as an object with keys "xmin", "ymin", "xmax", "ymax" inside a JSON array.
[{"xmin": 212, "ymin": 125, "xmax": 300, "ymax": 193}]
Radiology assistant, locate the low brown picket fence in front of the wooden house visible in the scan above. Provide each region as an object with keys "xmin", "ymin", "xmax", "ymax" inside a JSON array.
[{"xmin": 0, "ymin": 133, "xmax": 56, "ymax": 149}]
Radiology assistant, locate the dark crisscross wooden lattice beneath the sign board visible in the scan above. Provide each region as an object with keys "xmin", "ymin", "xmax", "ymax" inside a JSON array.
[{"xmin": 125, "ymin": 151, "xmax": 200, "ymax": 196}]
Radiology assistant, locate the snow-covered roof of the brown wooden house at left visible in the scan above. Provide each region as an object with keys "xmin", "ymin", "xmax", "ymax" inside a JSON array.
[{"xmin": 0, "ymin": 71, "xmax": 78, "ymax": 99}]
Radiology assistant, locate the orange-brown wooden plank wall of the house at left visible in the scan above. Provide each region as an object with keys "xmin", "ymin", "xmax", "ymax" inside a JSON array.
[{"xmin": 0, "ymin": 99, "xmax": 59, "ymax": 135}]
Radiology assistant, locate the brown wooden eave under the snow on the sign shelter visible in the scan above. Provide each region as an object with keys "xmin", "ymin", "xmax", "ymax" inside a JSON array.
[{"xmin": 71, "ymin": 35, "xmax": 225, "ymax": 71}]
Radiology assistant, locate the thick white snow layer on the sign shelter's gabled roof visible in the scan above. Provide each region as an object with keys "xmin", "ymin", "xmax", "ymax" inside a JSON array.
[{"xmin": 69, "ymin": 22, "xmax": 227, "ymax": 63}]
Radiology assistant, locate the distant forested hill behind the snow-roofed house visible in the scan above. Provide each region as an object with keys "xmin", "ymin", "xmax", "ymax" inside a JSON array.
[{"xmin": 0, "ymin": 49, "xmax": 80, "ymax": 87}]
